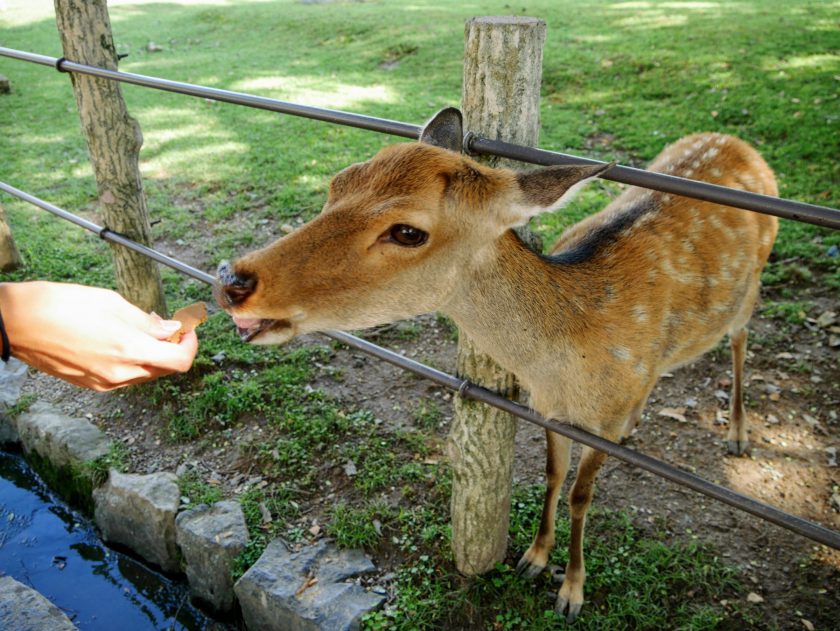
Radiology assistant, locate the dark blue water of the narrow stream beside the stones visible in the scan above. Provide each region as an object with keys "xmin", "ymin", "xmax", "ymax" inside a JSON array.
[{"xmin": 0, "ymin": 451, "xmax": 227, "ymax": 631}]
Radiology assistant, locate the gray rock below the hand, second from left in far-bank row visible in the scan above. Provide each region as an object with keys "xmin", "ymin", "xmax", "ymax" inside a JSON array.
[{"xmin": 16, "ymin": 401, "xmax": 110, "ymax": 467}]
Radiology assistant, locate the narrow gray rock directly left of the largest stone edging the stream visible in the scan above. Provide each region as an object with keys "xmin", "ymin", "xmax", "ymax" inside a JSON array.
[{"xmin": 175, "ymin": 501, "xmax": 248, "ymax": 611}]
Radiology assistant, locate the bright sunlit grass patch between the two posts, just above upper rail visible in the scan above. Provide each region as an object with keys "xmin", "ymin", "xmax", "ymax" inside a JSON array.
[{"xmin": 233, "ymin": 77, "xmax": 397, "ymax": 109}]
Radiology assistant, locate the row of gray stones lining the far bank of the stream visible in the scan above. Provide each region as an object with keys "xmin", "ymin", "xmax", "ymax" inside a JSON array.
[{"xmin": 0, "ymin": 359, "xmax": 385, "ymax": 631}]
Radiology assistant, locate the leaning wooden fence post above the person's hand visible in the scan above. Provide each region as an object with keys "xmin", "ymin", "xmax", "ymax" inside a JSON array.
[{"xmin": 55, "ymin": 0, "xmax": 166, "ymax": 315}]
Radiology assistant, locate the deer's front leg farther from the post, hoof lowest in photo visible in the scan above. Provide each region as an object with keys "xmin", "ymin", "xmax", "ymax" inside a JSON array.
[{"xmin": 554, "ymin": 447, "xmax": 607, "ymax": 622}]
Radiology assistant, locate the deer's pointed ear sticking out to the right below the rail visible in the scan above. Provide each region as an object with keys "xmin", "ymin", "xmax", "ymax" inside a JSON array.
[{"xmin": 511, "ymin": 162, "xmax": 615, "ymax": 225}]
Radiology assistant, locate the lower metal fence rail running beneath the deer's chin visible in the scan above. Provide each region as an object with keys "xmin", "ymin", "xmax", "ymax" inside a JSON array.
[{"xmin": 0, "ymin": 182, "xmax": 840, "ymax": 550}]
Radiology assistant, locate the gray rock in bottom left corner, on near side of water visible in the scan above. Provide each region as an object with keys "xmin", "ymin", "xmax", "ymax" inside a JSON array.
[{"xmin": 0, "ymin": 576, "xmax": 77, "ymax": 631}]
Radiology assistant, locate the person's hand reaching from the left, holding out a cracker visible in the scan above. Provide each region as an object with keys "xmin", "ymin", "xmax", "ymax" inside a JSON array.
[{"xmin": 0, "ymin": 281, "xmax": 198, "ymax": 392}]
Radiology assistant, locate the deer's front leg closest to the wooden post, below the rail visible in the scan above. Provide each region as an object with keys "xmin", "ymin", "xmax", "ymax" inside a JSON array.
[{"xmin": 516, "ymin": 431, "xmax": 572, "ymax": 579}]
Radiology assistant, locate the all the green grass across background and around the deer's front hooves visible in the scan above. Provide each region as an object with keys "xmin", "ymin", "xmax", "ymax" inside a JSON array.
[{"xmin": 0, "ymin": 0, "xmax": 840, "ymax": 629}]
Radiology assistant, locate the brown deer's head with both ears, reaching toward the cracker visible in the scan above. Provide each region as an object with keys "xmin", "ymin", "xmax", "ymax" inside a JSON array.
[{"xmin": 215, "ymin": 108, "xmax": 607, "ymax": 344}]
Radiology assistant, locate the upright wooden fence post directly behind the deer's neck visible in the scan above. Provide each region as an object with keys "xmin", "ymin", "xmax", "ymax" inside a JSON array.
[{"xmin": 448, "ymin": 17, "xmax": 545, "ymax": 575}]
